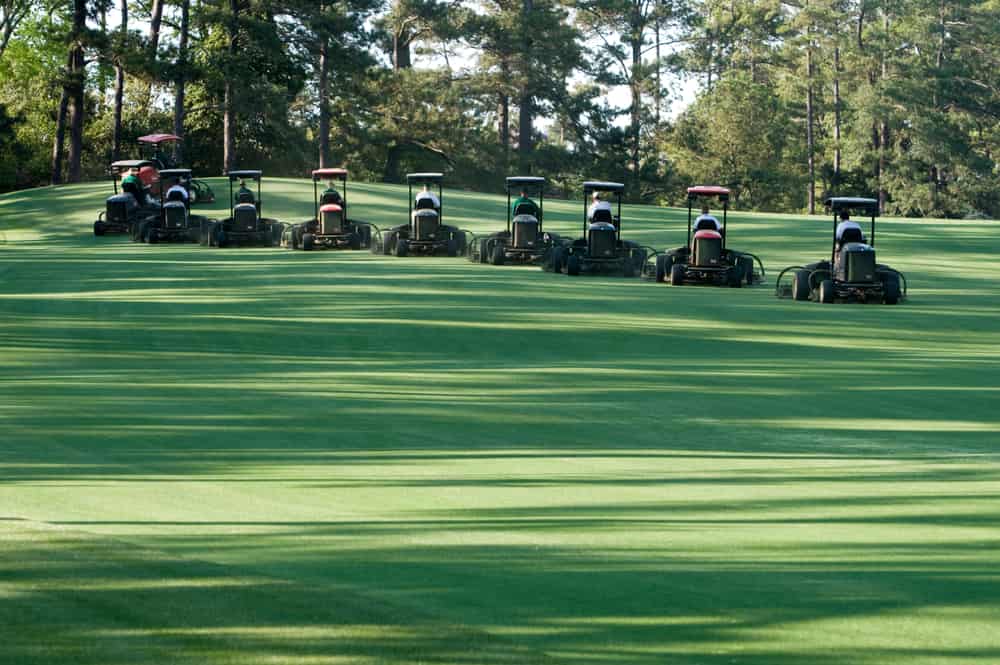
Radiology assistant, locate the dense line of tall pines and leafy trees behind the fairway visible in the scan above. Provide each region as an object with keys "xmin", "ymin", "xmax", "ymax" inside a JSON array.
[{"xmin": 0, "ymin": 0, "xmax": 1000, "ymax": 217}]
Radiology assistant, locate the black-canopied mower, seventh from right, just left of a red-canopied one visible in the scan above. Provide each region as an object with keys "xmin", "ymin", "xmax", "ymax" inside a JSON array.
[{"xmin": 199, "ymin": 170, "xmax": 285, "ymax": 247}]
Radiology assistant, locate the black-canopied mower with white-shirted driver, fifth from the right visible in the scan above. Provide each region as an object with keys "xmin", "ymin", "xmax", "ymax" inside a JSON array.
[{"xmin": 372, "ymin": 173, "xmax": 468, "ymax": 256}]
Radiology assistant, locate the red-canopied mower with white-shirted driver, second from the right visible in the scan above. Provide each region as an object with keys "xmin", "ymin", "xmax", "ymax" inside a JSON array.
[{"xmin": 645, "ymin": 185, "xmax": 764, "ymax": 288}]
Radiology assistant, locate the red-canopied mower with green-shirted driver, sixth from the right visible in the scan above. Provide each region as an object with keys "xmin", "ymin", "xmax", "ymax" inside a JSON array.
[{"xmin": 281, "ymin": 169, "xmax": 372, "ymax": 250}]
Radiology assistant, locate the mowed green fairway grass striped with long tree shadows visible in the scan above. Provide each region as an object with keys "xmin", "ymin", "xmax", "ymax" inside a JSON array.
[{"xmin": 0, "ymin": 179, "xmax": 1000, "ymax": 665}]
